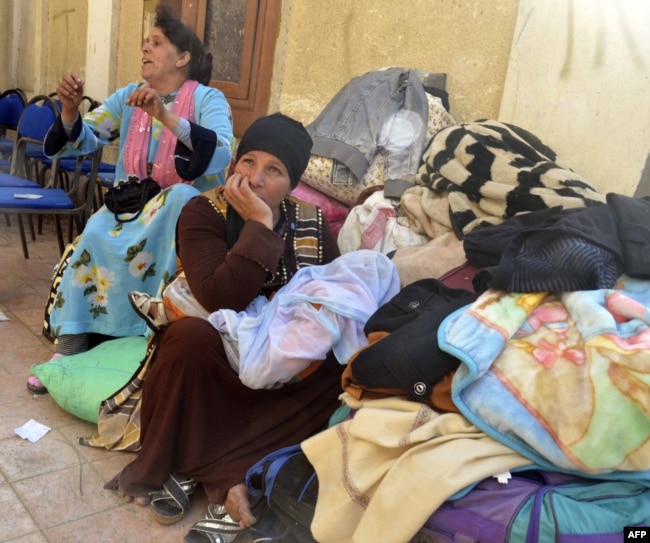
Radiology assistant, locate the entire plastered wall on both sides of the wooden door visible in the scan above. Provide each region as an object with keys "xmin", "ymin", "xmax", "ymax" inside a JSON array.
[{"xmin": 0, "ymin": 0, "xmax": 650, "ymax": 194}]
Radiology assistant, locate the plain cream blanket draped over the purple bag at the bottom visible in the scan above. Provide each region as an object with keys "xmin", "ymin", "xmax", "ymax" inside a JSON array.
[{"xmin": 302, "ymin": 393, "xmax": 531, "ymax": 543}]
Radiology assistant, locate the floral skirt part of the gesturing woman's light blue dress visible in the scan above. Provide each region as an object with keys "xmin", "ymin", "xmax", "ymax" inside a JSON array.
[{"xmin": 50, "ymin": 184, "xmax": 200, "ymax": 337}]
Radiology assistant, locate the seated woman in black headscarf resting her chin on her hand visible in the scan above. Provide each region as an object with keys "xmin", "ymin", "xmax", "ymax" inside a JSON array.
[{"xmin": 102, "ymin": 114, "xmax": 342, "ymax": 536}]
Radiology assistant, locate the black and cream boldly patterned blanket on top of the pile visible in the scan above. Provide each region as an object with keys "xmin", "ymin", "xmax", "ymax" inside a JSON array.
[{"xmin": 416, "ymin": 120, "xmax": 605, "ymax": 237}]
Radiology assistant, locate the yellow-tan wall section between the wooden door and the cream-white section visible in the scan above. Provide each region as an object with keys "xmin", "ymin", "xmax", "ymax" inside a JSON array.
[{"xmin": 275, "ymin": 0, "xmax": 518, "ymax": 122}]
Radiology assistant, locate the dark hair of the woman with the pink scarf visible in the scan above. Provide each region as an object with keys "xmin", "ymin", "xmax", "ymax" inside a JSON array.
[{"xmin": 154, "ymin": 4, "xmax": 212, "ymax": 85}]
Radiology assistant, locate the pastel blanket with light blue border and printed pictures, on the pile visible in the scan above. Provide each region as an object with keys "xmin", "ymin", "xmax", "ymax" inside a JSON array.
[{"xmin": 439, "ymin": 275, "xmax": 650, "ymax": 480}]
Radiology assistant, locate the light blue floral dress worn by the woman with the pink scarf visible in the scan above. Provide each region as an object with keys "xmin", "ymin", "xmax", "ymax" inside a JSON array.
[{"xmin": 43, "ymin": 83, "xmax": 233, "ymax": 337}]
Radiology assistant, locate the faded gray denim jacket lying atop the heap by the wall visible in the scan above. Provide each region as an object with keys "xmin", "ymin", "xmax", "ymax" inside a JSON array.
[{"xmin": 307, "ymin": 68, "xmax": 445, "ymax": 196}]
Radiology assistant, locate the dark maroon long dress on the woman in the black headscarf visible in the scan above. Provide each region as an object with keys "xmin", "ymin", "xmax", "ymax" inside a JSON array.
[{"xmin": 114, "ymin": 193, "xmax": 343, "ymax": 503}]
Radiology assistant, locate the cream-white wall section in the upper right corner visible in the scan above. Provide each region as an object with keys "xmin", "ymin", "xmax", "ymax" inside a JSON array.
[{"xmin": 499, "ymin": 0, "xmax": 650, "ymax": 195}]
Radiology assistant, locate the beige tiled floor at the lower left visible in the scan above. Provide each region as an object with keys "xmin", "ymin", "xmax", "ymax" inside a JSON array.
[{"xmin": 0, "ymin": 217, "xmax": 207, "ymax": 543}]
